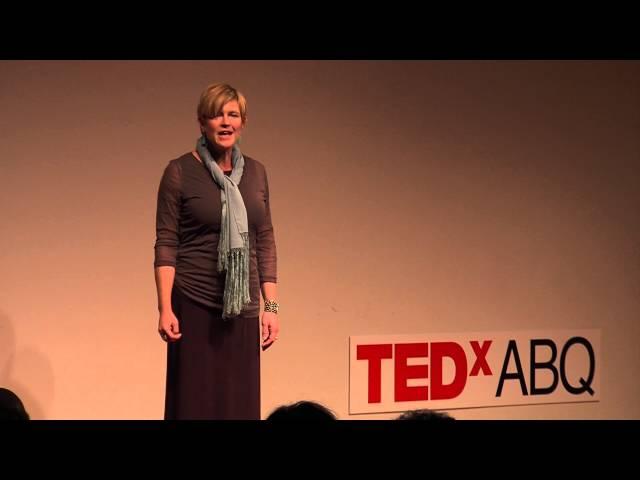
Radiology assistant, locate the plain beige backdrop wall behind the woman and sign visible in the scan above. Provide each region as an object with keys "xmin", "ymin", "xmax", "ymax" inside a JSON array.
[{"xmin": 0, "ymin": 61, "xmax": 640, "ymax": 419}]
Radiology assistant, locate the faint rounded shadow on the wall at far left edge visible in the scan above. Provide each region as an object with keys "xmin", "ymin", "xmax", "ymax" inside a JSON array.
[{"xmin": 0, "ymin": 311, "xmax": 54, "ymax": 420}]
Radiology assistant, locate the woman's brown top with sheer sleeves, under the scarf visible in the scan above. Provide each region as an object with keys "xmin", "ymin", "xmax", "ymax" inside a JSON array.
[{"xmin": 154, "ymin": 153, "xmax": 277, "ymax": 316}]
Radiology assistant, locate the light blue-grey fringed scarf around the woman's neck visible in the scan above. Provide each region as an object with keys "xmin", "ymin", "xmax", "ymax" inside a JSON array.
[{"xmin": 196, "ymin": 135, "xmax": 251, "ymax": 319}]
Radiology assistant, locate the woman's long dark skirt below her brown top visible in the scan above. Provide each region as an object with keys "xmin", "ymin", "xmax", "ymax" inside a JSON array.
[{"xmin": 164, "ymin": 286, "xmax": 260, "ymax": 420}]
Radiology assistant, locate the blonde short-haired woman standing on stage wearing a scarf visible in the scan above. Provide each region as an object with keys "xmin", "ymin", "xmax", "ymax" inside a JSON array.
[{"xmin": 154, "ymin": 83, "xmax": 280, "ymax": 420}]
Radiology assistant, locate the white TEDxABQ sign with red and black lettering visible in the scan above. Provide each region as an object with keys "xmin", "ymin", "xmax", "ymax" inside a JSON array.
[{"xmin": 349, "ymin": 330, "xmax": 600, "ymax": 414}]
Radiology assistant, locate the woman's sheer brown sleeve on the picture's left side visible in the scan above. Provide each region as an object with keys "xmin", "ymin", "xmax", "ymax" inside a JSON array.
[{"xmin": 153, "ymin": 161, "xmax": 182, "ymax": 267}]
